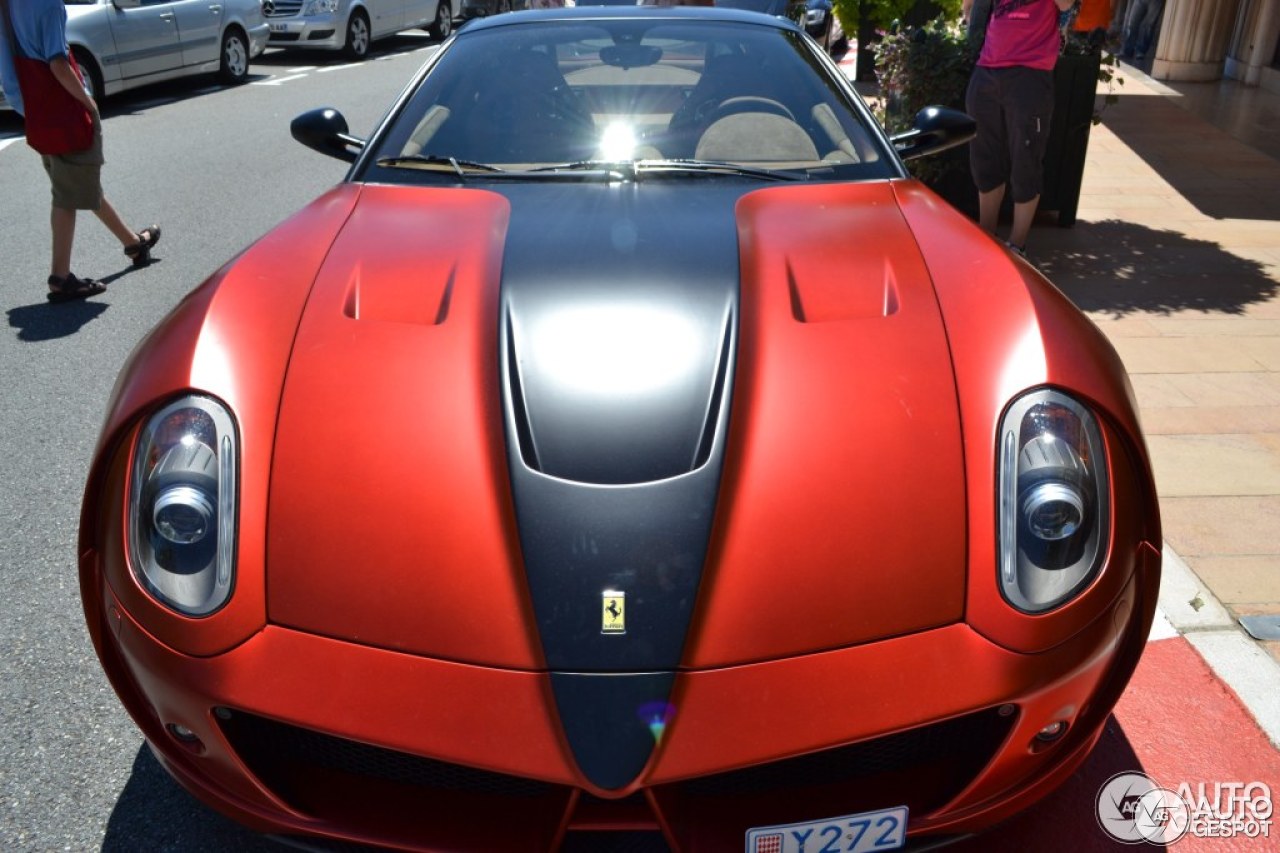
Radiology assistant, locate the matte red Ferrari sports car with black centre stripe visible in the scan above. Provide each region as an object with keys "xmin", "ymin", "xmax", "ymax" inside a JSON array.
[{"xmin": 79, "ymin": 8, "xmax": 1161, "ymax": 853}]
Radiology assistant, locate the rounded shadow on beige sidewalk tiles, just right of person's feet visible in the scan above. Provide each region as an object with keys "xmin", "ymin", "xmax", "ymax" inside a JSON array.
[{"xmin": 1032, "ymin": 219, "xmax": 1280, "ymax": 318}]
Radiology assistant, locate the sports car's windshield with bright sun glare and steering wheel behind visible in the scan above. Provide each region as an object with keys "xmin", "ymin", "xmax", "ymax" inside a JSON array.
[{"xmin": 362, "ymin": 18, "xmax": 891, "ymax": 182}]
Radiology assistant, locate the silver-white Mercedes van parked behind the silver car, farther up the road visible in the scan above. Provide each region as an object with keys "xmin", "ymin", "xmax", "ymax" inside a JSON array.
[{"xmin": 262, "ymin": 0, "xmax": 462, "ymax": 59}]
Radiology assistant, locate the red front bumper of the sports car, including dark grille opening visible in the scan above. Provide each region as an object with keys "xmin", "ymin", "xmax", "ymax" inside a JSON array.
[{"xmin": 87, "ymin": 544, "xmax": 1160, "ymax": 850}]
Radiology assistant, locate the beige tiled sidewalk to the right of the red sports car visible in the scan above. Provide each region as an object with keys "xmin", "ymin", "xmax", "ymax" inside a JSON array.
[{"xmin": 1029, "ymin": 68, "xmax": 1280, "ymax": 660}]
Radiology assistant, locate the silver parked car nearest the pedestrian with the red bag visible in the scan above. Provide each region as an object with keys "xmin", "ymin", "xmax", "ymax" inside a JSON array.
[{"xmin": 0, "ymin": 0, "xmax": 268, "ymax": 106}]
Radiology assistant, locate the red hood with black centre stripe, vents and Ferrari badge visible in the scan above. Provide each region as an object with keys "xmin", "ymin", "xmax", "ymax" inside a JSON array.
[{"xmin": 266, "ymin": 182, "xmax": 965, "ymax": 671}]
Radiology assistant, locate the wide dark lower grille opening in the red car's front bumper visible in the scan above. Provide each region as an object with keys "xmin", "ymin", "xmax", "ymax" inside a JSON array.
[{"xmin": 218, "ymin": 708, "xmax": 1015, "ymax": 853}]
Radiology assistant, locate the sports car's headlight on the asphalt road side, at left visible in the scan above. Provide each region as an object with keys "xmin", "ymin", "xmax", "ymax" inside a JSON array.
[{"xmin": 129, "ymin": 396, "xmax": 238, "ymax": 616}]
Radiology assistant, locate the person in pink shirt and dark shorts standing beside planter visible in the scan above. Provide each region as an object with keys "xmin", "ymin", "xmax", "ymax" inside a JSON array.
[{"xmin": 964, "ymin": 0, "xmax": 1073, "ymax": 256}]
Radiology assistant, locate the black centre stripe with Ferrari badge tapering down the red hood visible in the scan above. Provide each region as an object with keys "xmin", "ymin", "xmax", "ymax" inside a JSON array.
[{"xmin": 499, "ymin": 182, "xmax": 754, "ymax": 788}]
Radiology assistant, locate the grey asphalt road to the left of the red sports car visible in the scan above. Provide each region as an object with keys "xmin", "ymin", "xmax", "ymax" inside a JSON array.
[{"xmin": 0, "ymin": 32, "xmax": 434, "ymax": 852}]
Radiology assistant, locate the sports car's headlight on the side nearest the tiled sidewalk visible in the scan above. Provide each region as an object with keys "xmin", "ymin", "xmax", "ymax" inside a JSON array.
[{"xmin": 998, "ymin": 389, "xmax": 1111, "ymax": 613}]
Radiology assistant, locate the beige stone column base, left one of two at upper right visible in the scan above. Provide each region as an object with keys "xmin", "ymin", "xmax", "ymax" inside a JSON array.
[{"xmin": 1151, "ymin": 0, "xmax": 1240, "ymax": 81}]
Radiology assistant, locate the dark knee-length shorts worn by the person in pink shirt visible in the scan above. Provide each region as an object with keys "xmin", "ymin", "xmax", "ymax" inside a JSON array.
[{"xmin": 965, "ymin": 67, "xmax": 1053, "ymax": 202}]
